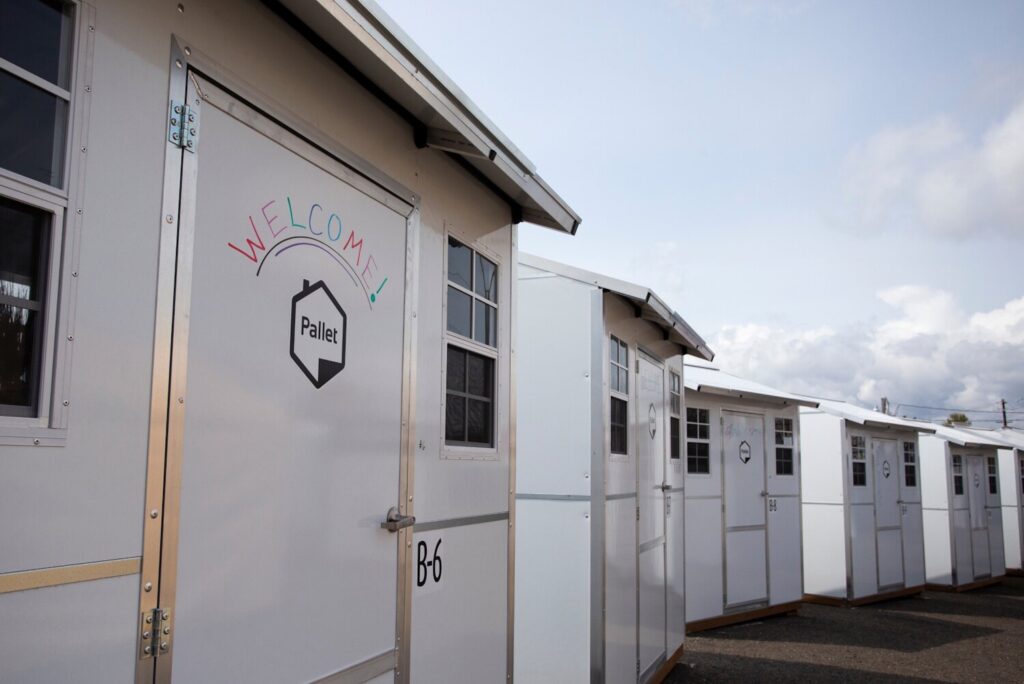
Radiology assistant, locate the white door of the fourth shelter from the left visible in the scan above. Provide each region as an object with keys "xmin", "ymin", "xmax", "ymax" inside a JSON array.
[{"xmin": 871, "ymin": 439, "xmax": 903, "ymax": 593}]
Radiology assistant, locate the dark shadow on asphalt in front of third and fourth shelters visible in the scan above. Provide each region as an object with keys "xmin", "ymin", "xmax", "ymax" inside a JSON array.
[{"xmin": 697, "ymin": 599, "xmax": 998, "ymax": 653}]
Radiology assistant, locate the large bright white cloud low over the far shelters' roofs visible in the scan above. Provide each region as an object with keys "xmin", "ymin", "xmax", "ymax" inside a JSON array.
[{"xmin": 711, "ymin": 286, "xmax": 1024, "ymax": 419}]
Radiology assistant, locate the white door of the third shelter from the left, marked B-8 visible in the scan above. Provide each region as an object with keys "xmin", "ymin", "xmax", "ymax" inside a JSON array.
[{"xmin": 722, "ymin": 411, "xmax": 768, "ymax": 610}]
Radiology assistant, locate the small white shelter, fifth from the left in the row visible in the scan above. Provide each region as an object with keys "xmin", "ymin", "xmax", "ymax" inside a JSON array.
[{"xmin": 921, "ymin": 425, "xmax": 1010, "ymax": 591}]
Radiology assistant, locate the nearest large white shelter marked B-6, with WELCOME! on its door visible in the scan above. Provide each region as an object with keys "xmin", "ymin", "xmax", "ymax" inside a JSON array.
[{"xmin": 0, "ymin": 0, "xmax": 580, "ymax": 684}]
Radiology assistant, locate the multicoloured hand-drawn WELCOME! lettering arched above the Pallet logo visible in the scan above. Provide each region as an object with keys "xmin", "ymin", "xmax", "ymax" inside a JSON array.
[{"xmin": 227, "ymin": 196, "xmax": 387, "ymax": 304}]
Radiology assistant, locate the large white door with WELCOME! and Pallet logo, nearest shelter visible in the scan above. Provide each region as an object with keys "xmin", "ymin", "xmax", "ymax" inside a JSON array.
[{"xmin": 150, "ymin": 77, "xmax": 411, "ymax": 684}]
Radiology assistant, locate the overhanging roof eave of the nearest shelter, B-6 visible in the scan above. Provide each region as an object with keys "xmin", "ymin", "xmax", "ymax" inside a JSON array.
[{"xmin": 271, "ymin": 0, "xmax": 581, "ymax": 233}]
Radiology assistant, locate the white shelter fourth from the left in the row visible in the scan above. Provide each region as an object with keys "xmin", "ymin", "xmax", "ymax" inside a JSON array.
[{"xmin": 800, "ymin": 399, "xmax": 934, "ymax": 605}]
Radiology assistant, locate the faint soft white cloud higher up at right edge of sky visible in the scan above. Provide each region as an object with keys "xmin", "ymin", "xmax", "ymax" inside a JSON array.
[{"xmin": 842, "ymin": 100, "xmax": 1024, "ymax": 237}]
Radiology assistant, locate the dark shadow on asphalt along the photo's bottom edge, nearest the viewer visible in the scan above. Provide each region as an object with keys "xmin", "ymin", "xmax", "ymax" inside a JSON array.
[{"xmin": 665, "ymin": 653, "xmax": 936, "ymax": 684}]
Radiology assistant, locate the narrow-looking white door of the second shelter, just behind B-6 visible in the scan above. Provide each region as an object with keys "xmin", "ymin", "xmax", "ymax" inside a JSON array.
[{"xmin": 637, "ymin": 358, "xmax": 668, "ymax": 675}]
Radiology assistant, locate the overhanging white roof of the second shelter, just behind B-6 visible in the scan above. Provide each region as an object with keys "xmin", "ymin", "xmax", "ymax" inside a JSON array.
[{"xmin": 519, "ymin": 252, "xmax": 715, "ymax": 360}]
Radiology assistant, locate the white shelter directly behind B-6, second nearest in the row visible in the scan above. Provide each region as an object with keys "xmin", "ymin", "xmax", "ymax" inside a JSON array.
[{"xmin": 515, "ymin": 254, "xmax": 712, "ymax": 684}]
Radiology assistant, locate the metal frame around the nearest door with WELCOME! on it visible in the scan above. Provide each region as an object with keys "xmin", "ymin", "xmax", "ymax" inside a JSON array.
[{"xmin": 135, "ymin": 35, "xmax": 420, "ymax": 684}]
